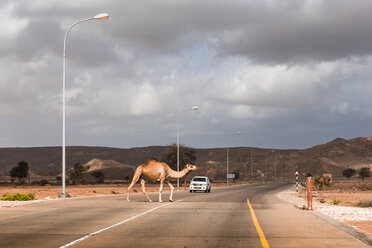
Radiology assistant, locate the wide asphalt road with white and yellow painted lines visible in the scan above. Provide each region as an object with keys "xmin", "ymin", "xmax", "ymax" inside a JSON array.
[{"xmin": 0, "ymin": 184, "xmax": 370, "ymax": 248}]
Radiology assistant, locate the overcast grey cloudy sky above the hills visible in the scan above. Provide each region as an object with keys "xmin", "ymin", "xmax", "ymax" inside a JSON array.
[{"xmin": 0, "ymin": 0, "xmax": 372, "ymax": 148}]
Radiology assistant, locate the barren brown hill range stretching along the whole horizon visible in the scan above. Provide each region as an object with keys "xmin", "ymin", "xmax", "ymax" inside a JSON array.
[{"xmin": 0, "ymin": 138, "xmax": 372, "ymax": 180}]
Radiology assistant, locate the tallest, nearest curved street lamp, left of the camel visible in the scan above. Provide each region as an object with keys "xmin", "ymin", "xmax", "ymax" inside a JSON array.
[{"xmin": 59, "ymin": 13, "xmax": 109, "ymax": 198}]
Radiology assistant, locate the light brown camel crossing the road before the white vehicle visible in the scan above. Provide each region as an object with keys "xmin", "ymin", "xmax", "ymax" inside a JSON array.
[{"xmin": 127, "ymin": 159, "xmax": 197, "ymax": 202}]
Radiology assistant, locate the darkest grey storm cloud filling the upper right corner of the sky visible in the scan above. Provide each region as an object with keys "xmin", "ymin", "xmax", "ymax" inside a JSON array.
[{"xmin": 220, "ymin": 1, "xmax": 372, "ymax": 63}]
